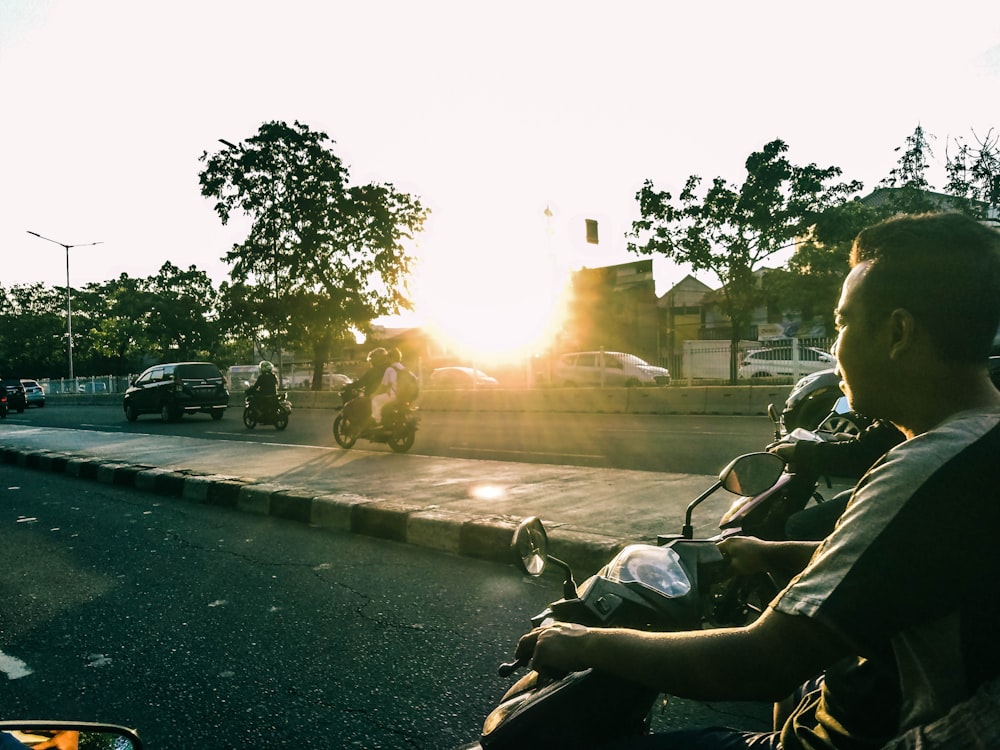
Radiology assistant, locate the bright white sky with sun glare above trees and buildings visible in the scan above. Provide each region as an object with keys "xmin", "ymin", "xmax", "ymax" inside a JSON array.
[{"xmin": 0, "ymin": 0, "xmax": 1000, "ymax": 362}]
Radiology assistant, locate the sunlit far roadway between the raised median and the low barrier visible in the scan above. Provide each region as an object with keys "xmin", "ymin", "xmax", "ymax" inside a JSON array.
[{"xmin": 0, "ymin": 399, "xmax": 773, "ymax": 475}]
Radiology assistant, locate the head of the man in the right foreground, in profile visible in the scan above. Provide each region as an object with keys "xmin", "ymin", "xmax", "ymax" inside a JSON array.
[{"xmin": 836, "ymin": 213, "xmax": 1000, "ymax": 419}]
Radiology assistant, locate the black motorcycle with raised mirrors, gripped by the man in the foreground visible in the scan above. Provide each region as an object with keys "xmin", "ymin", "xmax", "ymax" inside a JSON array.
[{"xmin": 467, "ymin": 452, "xmax": 816, "ymax": 750}]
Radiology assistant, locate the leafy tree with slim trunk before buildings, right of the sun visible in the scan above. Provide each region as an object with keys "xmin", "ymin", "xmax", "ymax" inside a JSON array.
[{"xmin": 628, "ymin": 140, "xmax": 861, "ymax": 382}]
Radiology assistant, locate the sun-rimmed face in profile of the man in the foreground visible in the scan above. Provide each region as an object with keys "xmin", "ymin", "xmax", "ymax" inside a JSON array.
[{"xmin": 833, "ymin": 263, "xmax": 889, "ymax": 417}]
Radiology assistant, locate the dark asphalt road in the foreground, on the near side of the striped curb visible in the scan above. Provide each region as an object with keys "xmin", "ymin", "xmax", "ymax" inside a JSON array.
[{"xmin": 0, "ymin": 468, "xmax": 767, "ymax": 749}]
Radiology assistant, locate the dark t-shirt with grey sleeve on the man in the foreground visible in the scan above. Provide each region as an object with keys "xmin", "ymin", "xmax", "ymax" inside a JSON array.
[{"xmin": 771, "ymin": 411, "xmax": 1000, "ymax": 750}]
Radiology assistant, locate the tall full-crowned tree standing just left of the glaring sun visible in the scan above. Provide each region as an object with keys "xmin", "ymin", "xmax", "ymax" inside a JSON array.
[{"xmin": 199, "ymin": 122, "xmax": 428, "ymax": 389}]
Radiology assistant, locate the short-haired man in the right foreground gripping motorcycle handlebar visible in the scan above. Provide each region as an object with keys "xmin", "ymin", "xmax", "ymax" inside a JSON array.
[{"xmin": 516, "ymin": 214, "xmax": 1000, "ymax": 750}]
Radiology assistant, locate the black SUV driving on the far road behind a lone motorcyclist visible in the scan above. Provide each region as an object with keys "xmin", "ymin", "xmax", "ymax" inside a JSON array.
[{"xmin": 122, "ymin": 362, "xmax": 229, "ymax": 422}]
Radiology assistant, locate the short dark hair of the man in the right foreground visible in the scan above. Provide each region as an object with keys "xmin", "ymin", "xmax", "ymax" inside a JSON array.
[{"xmin": 851, "ymin": 213, "xmax": 1000, "ymax": 362}]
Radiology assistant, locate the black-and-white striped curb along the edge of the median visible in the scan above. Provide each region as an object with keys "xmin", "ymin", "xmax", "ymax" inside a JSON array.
[{"xmin": 0, "ymin": 446, "xmax": 626, "ymax": 576}]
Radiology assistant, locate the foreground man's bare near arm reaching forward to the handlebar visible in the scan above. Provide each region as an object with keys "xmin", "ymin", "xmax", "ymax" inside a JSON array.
[{"xmin": 517, "ymin": 609, "xmax": 850, "ymax": 701}]
